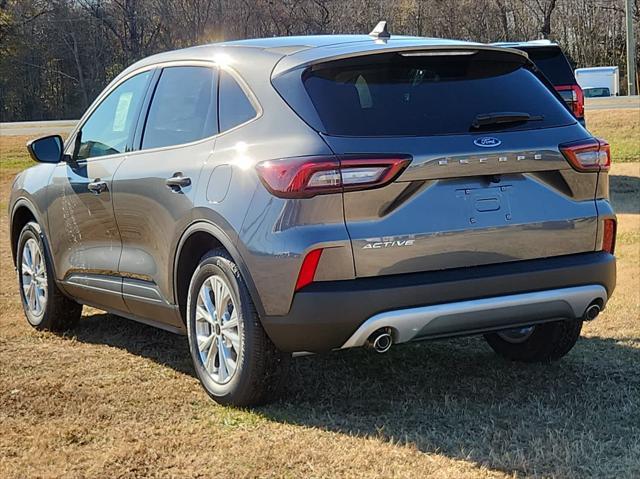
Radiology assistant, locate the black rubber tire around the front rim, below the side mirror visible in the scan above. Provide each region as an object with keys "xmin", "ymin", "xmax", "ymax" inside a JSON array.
[{"xmin": 16, "ymin": 222, "xmax": 82, "ymax": 332}]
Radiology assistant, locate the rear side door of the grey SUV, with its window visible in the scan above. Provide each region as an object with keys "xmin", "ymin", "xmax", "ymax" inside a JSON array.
[{"xmin": 113, "ymin": 62, "xmax": 218, "ymax": 328}]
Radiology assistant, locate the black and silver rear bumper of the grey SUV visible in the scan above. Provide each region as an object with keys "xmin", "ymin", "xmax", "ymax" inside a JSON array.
[{"xmin": 262, "ymin": 252, "xmax": 616, "ymax": 352}]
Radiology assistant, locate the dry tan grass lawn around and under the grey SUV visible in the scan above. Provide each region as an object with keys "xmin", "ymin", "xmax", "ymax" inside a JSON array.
[{"xmin": 0, "ymin": 111, "xmax": 640, "ymax": 479}]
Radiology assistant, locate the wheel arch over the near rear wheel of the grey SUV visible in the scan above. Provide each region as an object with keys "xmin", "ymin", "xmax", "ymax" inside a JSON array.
[{"xmin": 172, "ymin": 221, "xmax": 264, "ymax": 321}]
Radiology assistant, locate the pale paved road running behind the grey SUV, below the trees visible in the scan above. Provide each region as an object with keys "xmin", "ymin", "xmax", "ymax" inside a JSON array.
[{"xmin": 0, "ymin": 96, "xmax": 640, "ymax": 137}]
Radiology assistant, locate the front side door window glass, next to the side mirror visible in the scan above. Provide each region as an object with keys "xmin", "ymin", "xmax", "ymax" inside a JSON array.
[{"xmin": 76, "ymin": 71, "xmax": 151, "ymax": 159}]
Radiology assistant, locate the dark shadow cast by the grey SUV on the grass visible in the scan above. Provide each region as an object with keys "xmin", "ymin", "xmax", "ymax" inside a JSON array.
[{"xmin": 75, "ymin": 314, "xmax": 640, "ymax": 477}]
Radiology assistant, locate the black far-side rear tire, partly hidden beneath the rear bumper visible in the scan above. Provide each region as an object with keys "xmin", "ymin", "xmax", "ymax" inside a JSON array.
[{"xmin": 484, "ymin": 319, "xmax": 582, "ymax": 363}]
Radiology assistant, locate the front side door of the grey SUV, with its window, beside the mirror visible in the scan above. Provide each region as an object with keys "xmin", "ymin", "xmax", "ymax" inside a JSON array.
[{"xmin": 48, "ymin": 70, "xmax": 153, "ymax": 311}]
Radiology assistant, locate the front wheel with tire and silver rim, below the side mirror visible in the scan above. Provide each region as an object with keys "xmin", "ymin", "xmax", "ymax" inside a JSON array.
[{"xmin": 16, "ymin": 222, "xmax": 82, "ymax": 331}]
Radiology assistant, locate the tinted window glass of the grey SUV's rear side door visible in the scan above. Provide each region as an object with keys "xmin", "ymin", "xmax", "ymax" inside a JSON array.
[{"xmin": 142, "ymin": 66, "xmax": 218, "ymax": 148}]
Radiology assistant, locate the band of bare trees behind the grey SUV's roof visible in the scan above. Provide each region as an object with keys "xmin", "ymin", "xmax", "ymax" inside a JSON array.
[{"xmin": 0, "ymin": 0, "xmax": 640, "ymax": 120}]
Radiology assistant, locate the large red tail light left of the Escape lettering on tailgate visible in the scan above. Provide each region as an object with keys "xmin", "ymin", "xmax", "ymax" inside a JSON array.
[{"xmin": 256, "ymin": 155, "xmax": 411, "ymax": 198}]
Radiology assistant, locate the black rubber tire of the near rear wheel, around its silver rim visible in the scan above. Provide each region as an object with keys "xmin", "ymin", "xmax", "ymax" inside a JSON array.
[{"xmin": 187, "ymin": 249, "xmax": 291, "ymax": 407}]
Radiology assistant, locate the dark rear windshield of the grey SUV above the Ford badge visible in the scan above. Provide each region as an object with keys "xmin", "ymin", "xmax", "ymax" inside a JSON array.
[{"xmin": 284, "ymin": 52, "xmax": 575, "ymax": 136}]
